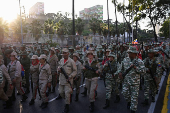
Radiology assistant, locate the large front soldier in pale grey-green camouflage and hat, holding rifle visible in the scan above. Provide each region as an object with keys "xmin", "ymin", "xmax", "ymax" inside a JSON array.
[{"xmin": 115, "ymin": 46, "xmax": 145, "ymax": 113}]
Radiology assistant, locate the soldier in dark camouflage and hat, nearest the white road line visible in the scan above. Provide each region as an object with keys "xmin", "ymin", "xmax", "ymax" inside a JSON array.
[{"xmin": 142, "ymin": 49, "xmax": 161, "ymax": 105}]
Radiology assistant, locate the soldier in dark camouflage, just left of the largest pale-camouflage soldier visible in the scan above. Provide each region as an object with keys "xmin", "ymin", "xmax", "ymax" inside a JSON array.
[{"xmin": 103, "ymin": 54, "xmax": 120, "ymax": 109}]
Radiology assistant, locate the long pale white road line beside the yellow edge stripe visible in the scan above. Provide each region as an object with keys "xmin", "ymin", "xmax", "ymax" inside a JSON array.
[{"xmin": 148, "ymin": 72, "xmax": 166, "ymax": 113}]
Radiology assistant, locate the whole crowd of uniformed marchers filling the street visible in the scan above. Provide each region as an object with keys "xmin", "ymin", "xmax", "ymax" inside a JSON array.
[{"xmin": 0, "ymin": 42, "xmax": 170, "ymax": 113}]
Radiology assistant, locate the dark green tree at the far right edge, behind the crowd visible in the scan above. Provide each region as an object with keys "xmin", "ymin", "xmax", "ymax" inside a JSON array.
[{"xmin": 160, "ymin": 18, "xmax": 170, "ymax": 38}]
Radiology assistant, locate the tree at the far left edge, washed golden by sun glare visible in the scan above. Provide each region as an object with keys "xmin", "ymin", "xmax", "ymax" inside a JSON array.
[{"xmin": 0, "ymin": 18, "xmax": 8, "ymax": 44}]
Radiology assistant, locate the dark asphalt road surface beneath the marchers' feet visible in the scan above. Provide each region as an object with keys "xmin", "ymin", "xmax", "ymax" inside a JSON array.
[{"xmin": 0, "ymin": 74, "xmax": 167, "ymax": 113}]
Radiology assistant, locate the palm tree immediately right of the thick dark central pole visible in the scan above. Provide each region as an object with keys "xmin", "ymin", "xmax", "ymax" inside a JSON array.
[{"xmin": 75, "ymin": 18, "xmax": 84, "ymax": 35}]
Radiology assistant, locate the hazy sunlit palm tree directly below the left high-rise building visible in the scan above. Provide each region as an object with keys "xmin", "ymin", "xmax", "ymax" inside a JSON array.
[{"xmin": 30, "ymin": 20, "xmax": 42, "ymax": 41}]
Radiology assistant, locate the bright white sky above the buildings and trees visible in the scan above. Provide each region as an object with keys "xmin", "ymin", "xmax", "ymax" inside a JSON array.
[{"xmin": 0, "ymin": 0, "xmax": 147, "ymax": 29}]
